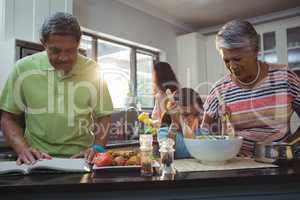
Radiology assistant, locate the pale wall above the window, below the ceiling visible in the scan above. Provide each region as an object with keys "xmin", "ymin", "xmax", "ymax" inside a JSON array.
[{"xmin": 73, "ymin": 0, "xmax": 188, "ymax": 71}]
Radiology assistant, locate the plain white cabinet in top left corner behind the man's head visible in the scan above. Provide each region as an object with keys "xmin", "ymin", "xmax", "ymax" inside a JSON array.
[{"xmin": 0, "ymin": 0, "xmax": 73, "ymax": 42}]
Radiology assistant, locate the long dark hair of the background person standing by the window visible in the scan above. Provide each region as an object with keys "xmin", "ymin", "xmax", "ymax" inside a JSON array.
[{"xmin": 153, "ymin": 62, "xmax": 179, "ymax": 92}]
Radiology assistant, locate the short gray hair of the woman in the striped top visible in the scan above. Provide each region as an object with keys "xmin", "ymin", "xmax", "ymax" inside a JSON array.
[{"xmin": 216, "ymin": 20, "xmax": 258, "ymax": 51}]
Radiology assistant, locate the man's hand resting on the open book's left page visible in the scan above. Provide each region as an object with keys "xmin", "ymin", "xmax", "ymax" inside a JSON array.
[{"xmin": 17, "ymin": 147, "xmax": 52, "ymax": 165}]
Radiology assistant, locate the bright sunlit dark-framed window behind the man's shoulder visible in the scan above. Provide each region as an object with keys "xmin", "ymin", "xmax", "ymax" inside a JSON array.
[{"xmin": 80, "ymin": 33, "xmax": 159, "ymax": 109}]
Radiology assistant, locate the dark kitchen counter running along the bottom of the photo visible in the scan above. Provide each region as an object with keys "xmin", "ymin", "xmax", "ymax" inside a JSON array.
[{"xmin": 0, "ymin": 161, "xmax": 300, "ymax": 200}]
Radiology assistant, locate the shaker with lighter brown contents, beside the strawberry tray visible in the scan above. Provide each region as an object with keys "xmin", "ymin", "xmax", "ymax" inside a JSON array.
[{"xmin": 139, "ymin": 134, "xmax": 153, "ymax": 176}]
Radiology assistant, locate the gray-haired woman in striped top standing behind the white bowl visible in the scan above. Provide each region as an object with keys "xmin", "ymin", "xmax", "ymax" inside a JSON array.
[{"xmin": 201, "ymin": 20, "xmax": 300, "ymax": 156}]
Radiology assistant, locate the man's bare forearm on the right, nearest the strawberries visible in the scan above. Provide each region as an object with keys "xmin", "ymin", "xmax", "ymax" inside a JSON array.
[{"xmin": 95, "ymin": 116, "xmax": 111, "ymax": 146}]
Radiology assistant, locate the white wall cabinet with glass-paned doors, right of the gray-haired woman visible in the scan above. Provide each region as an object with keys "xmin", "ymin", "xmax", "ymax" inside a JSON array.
[{"xmin": 255, "ymin": 16, "xmax": 300, "ymax": 70}]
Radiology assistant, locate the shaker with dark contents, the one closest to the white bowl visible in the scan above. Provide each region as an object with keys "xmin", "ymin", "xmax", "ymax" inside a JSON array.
[{"xmin": 159, "ymin": 138, "xmax": 176, "ymax": 176}]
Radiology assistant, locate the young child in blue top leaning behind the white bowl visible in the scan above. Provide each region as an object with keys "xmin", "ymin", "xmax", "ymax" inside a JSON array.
[{"xmin": 158, "ymin": 88, "xmax": 203, "ymax": 158}]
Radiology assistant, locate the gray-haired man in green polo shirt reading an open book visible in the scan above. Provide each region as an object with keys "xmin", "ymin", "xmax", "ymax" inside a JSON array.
[{"xmin": 0, "ymin": 13, "xmax": 112, "ymax": 164}]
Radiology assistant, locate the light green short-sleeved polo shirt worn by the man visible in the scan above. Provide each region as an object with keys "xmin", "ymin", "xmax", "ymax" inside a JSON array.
[{"xmin": 0, "ymin": 51, "xmax": 113, "ymax": 156}]
